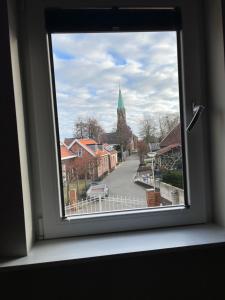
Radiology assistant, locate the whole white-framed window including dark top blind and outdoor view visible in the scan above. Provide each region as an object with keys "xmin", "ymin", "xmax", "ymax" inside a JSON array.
[{"xmin": 26, "ymin": 0, "xmax": 207, "ymax": 237}]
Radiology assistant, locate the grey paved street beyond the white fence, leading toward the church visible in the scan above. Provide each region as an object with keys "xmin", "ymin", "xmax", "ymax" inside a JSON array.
[{"xmin": 102, "ymin": 155, "xmax": 146, "ymax": 199}]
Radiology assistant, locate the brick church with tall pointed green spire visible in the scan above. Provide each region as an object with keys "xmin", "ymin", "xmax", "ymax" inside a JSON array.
[{"xmin": 101, "ymin": 88, "xmax": 138, "ymax": 160}]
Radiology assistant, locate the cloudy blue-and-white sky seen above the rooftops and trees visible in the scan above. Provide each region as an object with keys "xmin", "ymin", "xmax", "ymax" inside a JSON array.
[{"xmin": 52, "ymin": 32, "xmax": 179, "ymax": 140}]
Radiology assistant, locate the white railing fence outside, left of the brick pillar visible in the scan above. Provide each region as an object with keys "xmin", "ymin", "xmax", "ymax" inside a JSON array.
[{"xmin": 65, "ymin": 195, "xmax": 147, "ymax": 216}]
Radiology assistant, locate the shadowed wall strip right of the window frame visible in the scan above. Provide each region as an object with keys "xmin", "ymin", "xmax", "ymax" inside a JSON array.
[{"xmin": 205, "ymin": 0, "xmax": 225, "ymax": 226}]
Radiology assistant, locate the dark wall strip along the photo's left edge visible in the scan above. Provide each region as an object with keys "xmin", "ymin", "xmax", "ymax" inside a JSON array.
[{"xmin": 0, "ymin": 0, "xmax": 27, "ymax": 256}]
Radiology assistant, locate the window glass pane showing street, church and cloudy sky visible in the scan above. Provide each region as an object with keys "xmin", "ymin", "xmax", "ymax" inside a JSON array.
[{"xmin": 51, "ymin": 31, "xmax": 184, "ymax": 215}]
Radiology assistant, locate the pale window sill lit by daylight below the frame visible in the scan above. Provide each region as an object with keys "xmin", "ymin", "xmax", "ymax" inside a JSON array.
[{"xmin": 0, "ymin": 224, "xmax": 225, "ymax": 270}]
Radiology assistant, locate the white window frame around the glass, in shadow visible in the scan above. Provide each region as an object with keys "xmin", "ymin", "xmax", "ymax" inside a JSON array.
[{"xmin": 23, "ymin": 0, "xmax": 209, "ymax": 239}]
